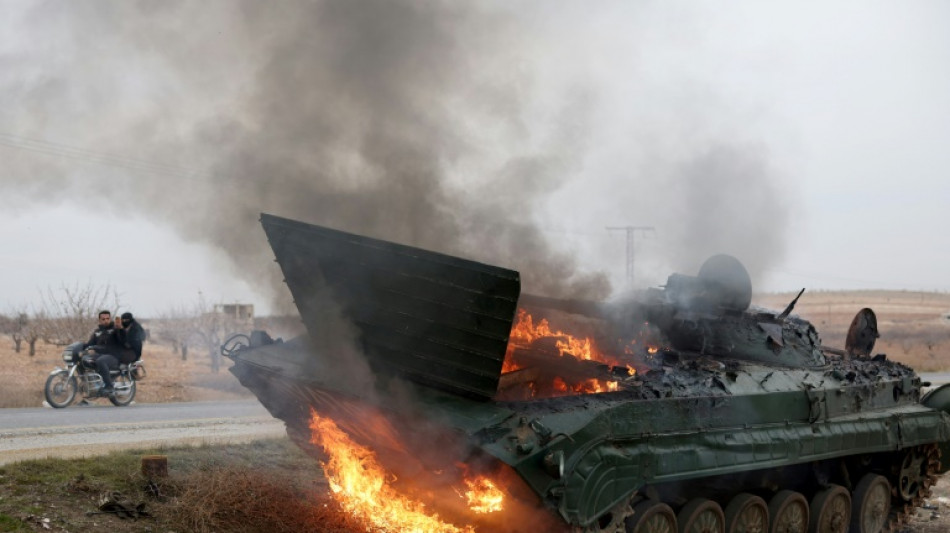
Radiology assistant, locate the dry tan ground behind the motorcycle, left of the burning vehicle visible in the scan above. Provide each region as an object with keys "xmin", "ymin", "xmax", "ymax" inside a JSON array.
[{"xmin": 0, "ymin": 336, "xmax": 253, "ymax": 408}]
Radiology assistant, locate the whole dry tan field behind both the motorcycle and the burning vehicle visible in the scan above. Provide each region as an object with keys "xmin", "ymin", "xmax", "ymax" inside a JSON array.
[{"xmin": 0, "ymin": 291, "xmax": 950, "ymax": 408}]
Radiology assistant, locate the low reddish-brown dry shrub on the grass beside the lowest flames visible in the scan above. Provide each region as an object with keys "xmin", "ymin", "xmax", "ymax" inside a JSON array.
[{"xmin": 166, "ymin": 467, "xmax": 360, "ymax": 533}]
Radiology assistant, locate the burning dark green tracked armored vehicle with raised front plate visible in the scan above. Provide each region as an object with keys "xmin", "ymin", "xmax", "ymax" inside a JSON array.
[{"xmin": 222, "ymin": 214, "xmax": 950, "ymax": 533}]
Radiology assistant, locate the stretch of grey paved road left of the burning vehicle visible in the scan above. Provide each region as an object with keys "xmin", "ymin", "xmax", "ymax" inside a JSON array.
[{"xmin": 0, "ymin": 400, "xmax": 285, "ymax": 464}]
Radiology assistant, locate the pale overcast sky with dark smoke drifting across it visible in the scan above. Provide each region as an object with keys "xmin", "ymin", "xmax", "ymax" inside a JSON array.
[{"xmin": 0, "ymin": 0, "xmax": 950, "ymax": 315}]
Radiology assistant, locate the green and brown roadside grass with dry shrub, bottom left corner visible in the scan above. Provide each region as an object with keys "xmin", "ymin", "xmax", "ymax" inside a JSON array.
[{"xmin": 0, "ymin": 438, "xmax": 361, "ymax": 533}]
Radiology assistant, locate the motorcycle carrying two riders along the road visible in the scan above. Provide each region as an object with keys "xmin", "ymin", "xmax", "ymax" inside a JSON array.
[{"xmin": 43, "ymin": 342, "xmax": 145, "ymax": 409}]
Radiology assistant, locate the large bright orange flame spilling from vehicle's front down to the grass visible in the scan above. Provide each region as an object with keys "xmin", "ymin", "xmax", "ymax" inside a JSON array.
[{"xmin": 310, "ymin": 411, "xmax": 475, "ymax": 533}]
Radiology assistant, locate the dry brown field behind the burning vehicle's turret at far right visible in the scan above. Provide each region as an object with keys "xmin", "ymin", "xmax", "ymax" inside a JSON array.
[{"xmin": 752, "ymin": 291, "xmax": 950, "ymax": 372}]
